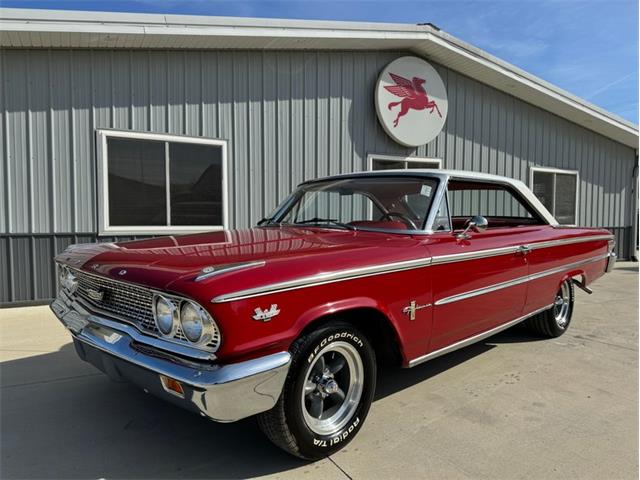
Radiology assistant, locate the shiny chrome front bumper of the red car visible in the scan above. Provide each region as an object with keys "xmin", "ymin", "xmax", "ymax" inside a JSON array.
[{"xmin": 51, "ymin": 295, "xmax": 291, "ymax": 422}]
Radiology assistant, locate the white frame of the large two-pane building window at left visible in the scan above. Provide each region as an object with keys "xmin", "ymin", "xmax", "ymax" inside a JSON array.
[{"xmin": 96, "ymin": 129, "xmax": 229, "ymax": 235}]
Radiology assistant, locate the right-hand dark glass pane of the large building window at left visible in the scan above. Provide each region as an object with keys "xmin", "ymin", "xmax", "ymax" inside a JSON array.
[{"xmin": 169, "ymin": 143, "xmax": 222, "ymax": 225}]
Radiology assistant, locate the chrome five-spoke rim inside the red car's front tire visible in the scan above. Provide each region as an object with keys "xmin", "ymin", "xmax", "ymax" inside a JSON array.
[{"xmin": 301, "ymin": 342, "xmax": 364, "ymax": 435}]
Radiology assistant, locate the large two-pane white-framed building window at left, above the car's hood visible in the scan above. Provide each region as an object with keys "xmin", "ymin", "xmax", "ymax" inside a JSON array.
[{"xmin": 98, "ymin": 130, "xmax": 227, "ymax": 235}]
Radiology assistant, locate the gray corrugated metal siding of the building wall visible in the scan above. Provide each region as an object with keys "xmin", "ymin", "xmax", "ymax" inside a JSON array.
[{"xmin": 0, "ymin": 50, "xmax": 635, "ymax": 303}]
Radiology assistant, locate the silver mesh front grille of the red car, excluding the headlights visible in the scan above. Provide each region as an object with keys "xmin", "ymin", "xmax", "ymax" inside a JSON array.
[{"xmin": 73, "ymin": 269, "xmax": 221, "ymax": 351}]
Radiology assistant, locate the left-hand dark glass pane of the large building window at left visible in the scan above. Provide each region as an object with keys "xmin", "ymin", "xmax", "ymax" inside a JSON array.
[{"xmin": 107, "ymin": 138, "xmax": 167, "ymax": 226}]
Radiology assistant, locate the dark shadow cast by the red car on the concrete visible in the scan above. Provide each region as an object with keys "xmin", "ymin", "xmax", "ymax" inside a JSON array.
[{"xmin": 0, "ymin": 333, "xmax": 536, "ymax": 478}]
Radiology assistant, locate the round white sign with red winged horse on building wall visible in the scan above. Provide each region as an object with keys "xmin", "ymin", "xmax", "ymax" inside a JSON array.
[{"xmin": 375, "ymin": 57, "xmax": 449, "ymax": 147}]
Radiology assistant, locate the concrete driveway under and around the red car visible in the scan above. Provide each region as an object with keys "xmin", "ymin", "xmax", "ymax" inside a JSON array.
[{"xmin": 0, "ymin": 263, "xmax": 638, "ymax": 480}]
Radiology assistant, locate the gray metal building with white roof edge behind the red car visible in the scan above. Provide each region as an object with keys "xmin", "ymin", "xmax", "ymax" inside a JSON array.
[{"xmin": 0, "ymin": 9, "xmax": 638, "ymax": 305}]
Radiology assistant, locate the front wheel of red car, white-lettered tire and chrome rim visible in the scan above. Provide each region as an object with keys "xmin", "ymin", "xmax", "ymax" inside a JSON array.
[{"xmin": 258, "ymin": 322, "xmax": 376, "ymax": 460}]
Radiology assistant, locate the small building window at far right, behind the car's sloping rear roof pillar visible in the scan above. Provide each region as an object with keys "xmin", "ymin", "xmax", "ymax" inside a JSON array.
[{"xmin": 530, "ymin": 167, "xmax": 578, "ymax": 225}]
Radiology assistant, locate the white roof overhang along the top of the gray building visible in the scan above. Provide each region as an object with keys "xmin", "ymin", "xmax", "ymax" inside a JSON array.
[{"xmin": 0, "ymin": 8, "xmax": 638, "ymax": 151}]
